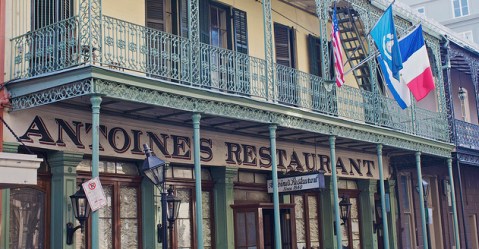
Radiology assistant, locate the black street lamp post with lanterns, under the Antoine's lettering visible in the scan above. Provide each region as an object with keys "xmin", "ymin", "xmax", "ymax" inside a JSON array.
[{"xmin": 139, "ymin": 144, "xmax": 181, "ymax": 249}]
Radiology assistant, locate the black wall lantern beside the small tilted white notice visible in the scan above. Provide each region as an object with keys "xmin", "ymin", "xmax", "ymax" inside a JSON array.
[{"xmin": 67, "ymin": 184, "xmax": 91, "ymax": 245}]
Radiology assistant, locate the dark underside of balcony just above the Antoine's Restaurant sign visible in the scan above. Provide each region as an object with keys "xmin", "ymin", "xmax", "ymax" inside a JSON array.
[{"xmin": 54, "ymin": 97, "xmax": 422, "ymax": 158}]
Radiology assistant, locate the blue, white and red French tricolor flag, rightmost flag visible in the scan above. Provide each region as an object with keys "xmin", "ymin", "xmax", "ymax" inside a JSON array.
[{"xmin": 399, "ymin": 25, "xmax": 434, "ymax": 101}]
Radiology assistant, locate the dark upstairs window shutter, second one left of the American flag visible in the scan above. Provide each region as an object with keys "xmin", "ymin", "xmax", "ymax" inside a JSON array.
[{"xmin": 274, "ymin": 23, "xmax": 293, "ymax": 67}]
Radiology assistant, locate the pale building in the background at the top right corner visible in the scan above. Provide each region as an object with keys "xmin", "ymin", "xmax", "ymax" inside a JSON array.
[{"xmin": 400, "ymin": 0, "xmax": 479, "ymax": 43}]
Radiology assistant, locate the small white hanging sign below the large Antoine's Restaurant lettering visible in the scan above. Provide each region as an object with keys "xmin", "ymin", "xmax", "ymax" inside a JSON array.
[{"xmin": 268, "ymin": 173, "xmax": 324, "ymax": 193}]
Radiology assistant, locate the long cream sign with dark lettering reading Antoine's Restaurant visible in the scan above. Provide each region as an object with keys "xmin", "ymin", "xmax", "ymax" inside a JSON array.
[{"xmin": 5, "ymin": 107, "xmax": 388, "ymax": 179}]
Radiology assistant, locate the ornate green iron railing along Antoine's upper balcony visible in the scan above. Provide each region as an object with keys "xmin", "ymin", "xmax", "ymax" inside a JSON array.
[{"xmin": 7, "ymin": 16, "xmax": 449, "ymax": 141}]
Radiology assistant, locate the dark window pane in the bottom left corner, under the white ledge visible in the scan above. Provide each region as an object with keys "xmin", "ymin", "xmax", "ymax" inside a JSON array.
[{"xmin": 9, "ymin": 188, "xmax": 45, "ymax": 249}]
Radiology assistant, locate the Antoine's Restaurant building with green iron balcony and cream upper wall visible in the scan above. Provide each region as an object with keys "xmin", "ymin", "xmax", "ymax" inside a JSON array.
[{"xmin": 0, "ymin": 0, "xmax": 464, "ymax": 249}]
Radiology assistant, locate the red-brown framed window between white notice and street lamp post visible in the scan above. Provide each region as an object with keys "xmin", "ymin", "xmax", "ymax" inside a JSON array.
[{"xmin": 75, "ymin": 160, "xmax": 142, "ymax": 249}]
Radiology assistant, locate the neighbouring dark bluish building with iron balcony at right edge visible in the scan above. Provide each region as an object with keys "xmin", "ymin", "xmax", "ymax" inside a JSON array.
[{"xmin": 443, "ymin": 39, "xmax": 479, "ymax": 248}]
